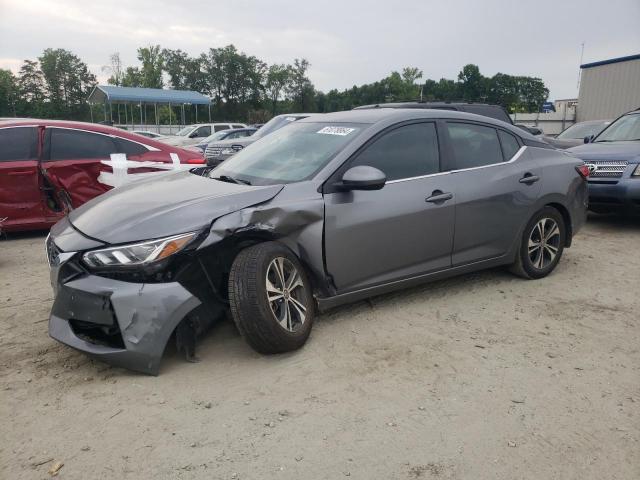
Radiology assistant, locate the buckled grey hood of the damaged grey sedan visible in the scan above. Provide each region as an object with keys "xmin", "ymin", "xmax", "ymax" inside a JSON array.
[{"xmin": 69, "ymin": 172, "xmax": 282, "ymax": 244}]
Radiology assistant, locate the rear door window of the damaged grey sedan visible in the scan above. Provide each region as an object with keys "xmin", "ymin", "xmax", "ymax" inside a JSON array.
[{"xmin": 447, "ymin": 122, "xmax": 503, "ymax": 170}]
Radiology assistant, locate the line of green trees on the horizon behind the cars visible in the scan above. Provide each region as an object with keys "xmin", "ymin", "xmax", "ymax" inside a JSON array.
[{"xmin": 0, "ymin": 45, "xmax": 549, "ymax": 124}]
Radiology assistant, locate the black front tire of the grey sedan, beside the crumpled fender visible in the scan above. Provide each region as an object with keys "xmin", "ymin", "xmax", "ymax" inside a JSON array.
[{"xmin": 229, "ymin": 242, "xmax": 315, "ymax": 354}]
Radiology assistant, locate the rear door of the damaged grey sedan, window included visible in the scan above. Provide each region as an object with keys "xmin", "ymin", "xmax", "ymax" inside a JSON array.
[{"xmin": 445, "ymin": 121, "xmax": 542, "ymax": 267}]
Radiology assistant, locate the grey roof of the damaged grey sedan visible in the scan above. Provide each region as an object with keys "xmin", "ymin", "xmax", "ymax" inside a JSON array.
[{"xmin": 298, "ymin": 108, "xmax": 537, "ymax": 140}]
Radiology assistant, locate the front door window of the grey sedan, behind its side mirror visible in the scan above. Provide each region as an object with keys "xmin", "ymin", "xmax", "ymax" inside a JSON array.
[{"xmin": 350, "ymin": 122, "xmax": 440, "ymax": 181}]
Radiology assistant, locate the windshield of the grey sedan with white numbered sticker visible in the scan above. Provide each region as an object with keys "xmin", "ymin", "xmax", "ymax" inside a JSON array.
[{"xmin": 209, "ymin": 123, "xmax": 363, "ymax": 185}]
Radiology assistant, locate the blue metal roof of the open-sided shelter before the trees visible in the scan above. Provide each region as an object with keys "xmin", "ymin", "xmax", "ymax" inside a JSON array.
[{"xmin": 88, "ymin": 85, "xmax": 211, "ymax": 105}]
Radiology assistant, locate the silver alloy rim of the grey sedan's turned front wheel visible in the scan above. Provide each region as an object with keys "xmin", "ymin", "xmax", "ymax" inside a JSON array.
[{"xmin": 266, "ymin": 257, "xmax": 307, "ymax": 332}]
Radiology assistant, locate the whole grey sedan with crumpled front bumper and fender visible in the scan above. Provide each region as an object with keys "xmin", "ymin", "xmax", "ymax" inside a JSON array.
[{"xmin": 47, "ymin": 108, "xmax": 588, "ymax": 374}]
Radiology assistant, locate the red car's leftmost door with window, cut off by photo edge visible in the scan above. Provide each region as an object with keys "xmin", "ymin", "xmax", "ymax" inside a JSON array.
[{"xmin": 0, "ymin": 126, "xmax": 44, "ymax": 231}]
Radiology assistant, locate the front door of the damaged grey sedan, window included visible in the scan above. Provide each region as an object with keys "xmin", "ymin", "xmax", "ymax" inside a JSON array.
[{"xmin": 324, "ymin": 122, "xmax": 455, "ymax": 293}]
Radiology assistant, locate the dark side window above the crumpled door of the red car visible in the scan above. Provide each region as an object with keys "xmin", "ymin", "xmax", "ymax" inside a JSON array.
[{"xmin": 49, "ymin": 128, "xmax": 118, "ymax": 160}]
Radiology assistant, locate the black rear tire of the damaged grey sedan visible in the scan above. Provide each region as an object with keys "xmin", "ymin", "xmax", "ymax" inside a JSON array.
[{"xmin": 510, "ymin": 207, "xmax": 567, "ymax": 279}]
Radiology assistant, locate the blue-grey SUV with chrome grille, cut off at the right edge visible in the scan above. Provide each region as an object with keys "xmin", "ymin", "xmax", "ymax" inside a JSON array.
[{"xmin": 567, "ymin": 109, "xmax": 640, "ymax": 214}]
